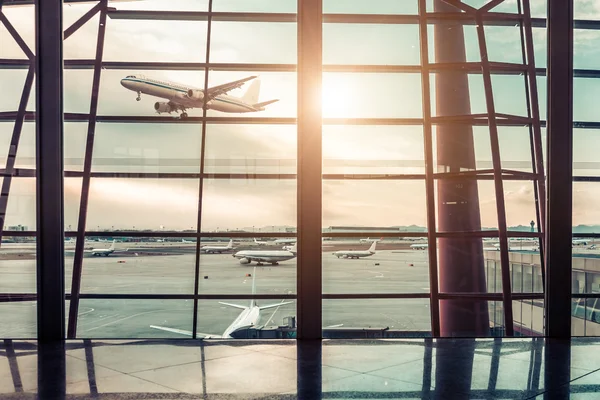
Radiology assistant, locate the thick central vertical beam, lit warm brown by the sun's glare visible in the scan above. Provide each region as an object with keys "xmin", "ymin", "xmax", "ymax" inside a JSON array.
[{"xmin": 296, "ymin": 0, "xmax": 323, "ymax": 340}]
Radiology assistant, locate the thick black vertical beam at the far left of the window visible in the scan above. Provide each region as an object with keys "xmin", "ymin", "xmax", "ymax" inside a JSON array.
[{"xmin": 35, "ymin": 0, "xmax": 65, "ymax": 340}]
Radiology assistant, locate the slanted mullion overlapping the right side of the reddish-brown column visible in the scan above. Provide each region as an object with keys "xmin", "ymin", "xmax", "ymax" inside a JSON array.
[{"xmin": 476, "ymin": 13, "xmax": 514, "ymax": 336}]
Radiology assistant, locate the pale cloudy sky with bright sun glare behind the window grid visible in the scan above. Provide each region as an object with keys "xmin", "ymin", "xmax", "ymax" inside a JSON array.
[{"xmin": 0, "ymin": 0, "xmax": 600, "ymax": 231}]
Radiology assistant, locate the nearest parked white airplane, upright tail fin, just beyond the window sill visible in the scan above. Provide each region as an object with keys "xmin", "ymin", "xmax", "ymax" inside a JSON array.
[{"xmin": 150, "ymin": 267, "xmax": 293, "ymax": 339}]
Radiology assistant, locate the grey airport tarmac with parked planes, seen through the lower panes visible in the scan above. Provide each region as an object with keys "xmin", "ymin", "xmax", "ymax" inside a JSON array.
[{"xmin": 0, "ymin": 245, "xmax": 430, "ymax": 338}]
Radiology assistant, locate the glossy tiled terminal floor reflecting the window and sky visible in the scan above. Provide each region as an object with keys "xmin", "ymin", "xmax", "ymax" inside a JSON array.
[{"xmin": 0, "ymin": 338, "xmax": 600, "ymax": 399}]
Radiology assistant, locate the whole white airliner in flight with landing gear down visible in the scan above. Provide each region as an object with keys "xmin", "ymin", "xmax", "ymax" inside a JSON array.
[{"xmin": 121, "ymin": 75, "xmax": 279, "ymax": 119}]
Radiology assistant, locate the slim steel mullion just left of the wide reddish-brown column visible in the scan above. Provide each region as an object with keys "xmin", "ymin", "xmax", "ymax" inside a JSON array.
[{"xmin": 419, "ymin": 0, "xmax": 440, "ymax": 337}]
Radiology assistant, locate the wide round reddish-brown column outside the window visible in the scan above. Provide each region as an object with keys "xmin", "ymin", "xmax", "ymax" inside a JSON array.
[{"xmin": 434, "ymin": 0, "xmax": 489, "ymax": 336}]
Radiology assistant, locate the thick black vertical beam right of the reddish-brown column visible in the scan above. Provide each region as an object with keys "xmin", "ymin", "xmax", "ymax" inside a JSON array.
[{"xmin": 545, "ymin": 0, "xmax": 573, "ymax": 338}]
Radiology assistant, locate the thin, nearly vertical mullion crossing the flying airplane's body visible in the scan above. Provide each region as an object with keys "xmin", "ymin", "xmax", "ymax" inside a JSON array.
[{"xmin": 192, "ymin": 0, "xmax": 213, "ymax": 339}]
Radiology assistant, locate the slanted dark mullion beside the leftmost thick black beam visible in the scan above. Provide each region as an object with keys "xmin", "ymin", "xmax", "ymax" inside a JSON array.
[{"xmin": 68, "ymin": 0, "xmax": 108, "ymax": 339}]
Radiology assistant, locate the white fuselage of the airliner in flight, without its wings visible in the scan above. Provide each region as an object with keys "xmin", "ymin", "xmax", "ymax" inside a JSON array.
[{"xmin": 121, "ymin": 77, "xmax": 261, "ymax": 113}]
